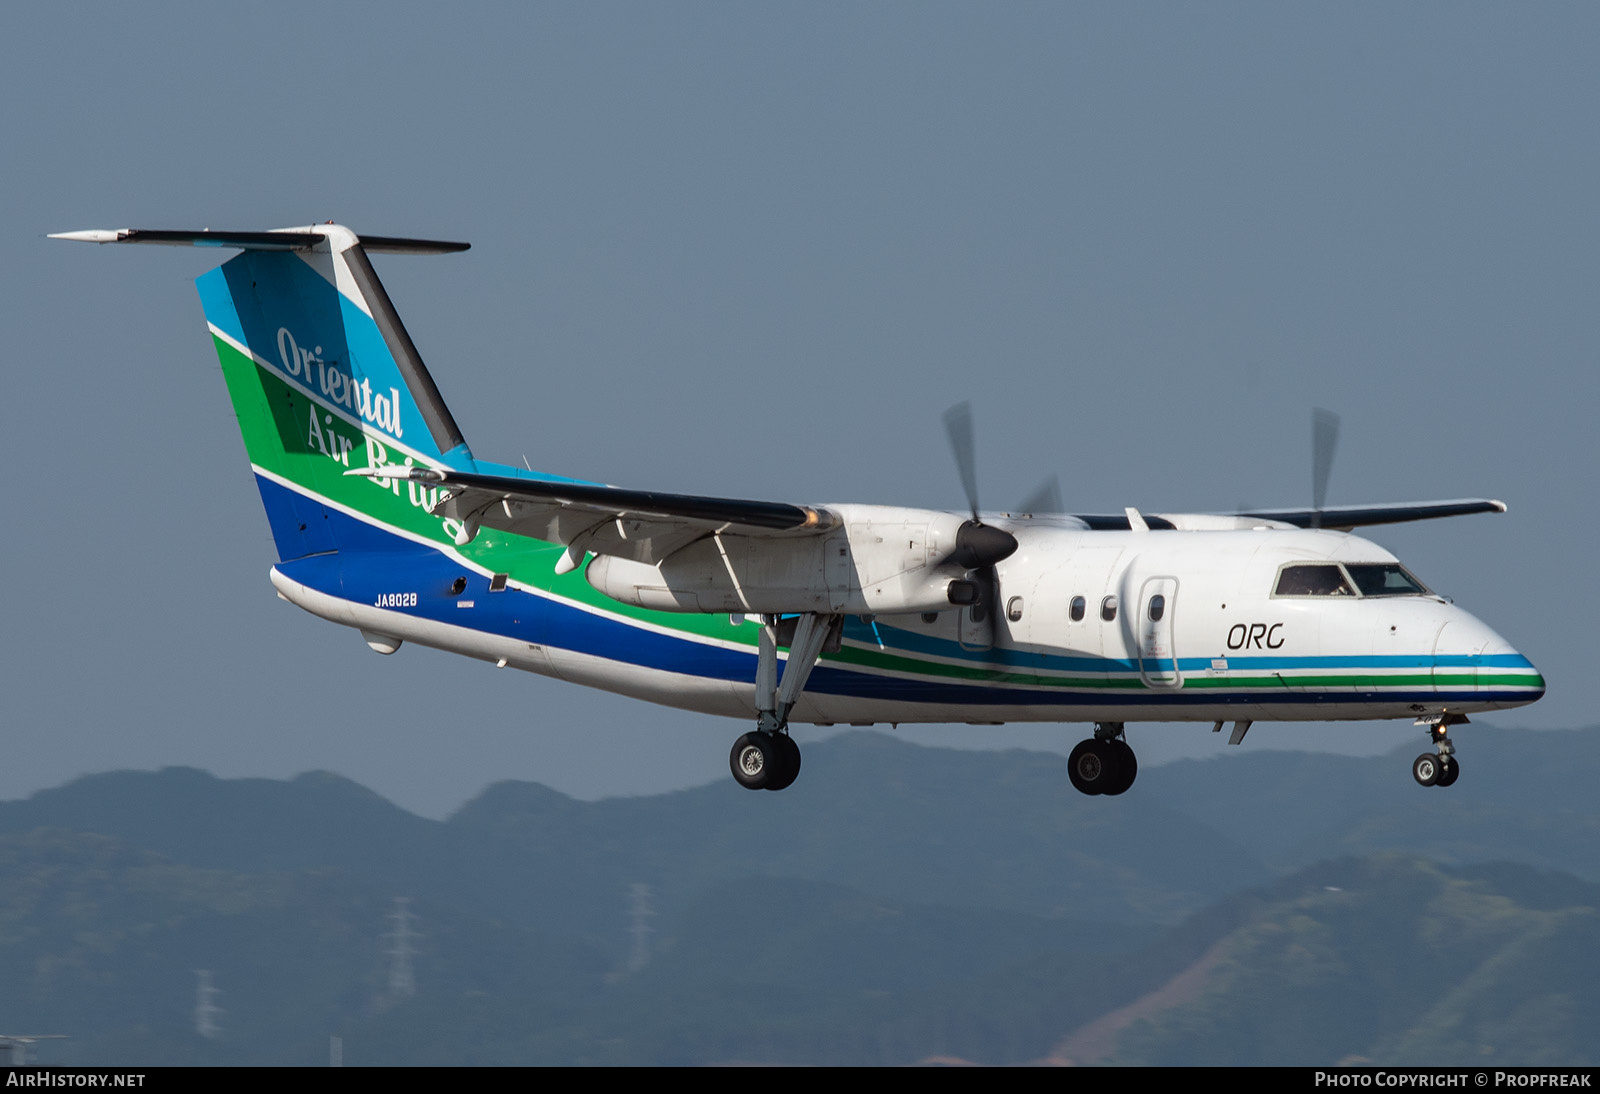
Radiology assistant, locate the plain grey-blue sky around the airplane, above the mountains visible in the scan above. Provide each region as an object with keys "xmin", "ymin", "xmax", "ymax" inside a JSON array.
[{"xmin": 0, "ymin": 3, "xmax": 1600, "ymax": 816}]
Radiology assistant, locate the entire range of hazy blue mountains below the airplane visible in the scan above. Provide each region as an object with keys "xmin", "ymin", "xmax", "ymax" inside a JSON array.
[{"xmin": 0, "ymin": 722, "xmax": 1600, "ymax": 1065}]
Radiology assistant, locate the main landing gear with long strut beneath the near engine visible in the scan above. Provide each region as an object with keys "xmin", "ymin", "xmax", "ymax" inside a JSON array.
[{"xmin": 728, "ymin": 613, "xmax": 845, "ymax": 790}]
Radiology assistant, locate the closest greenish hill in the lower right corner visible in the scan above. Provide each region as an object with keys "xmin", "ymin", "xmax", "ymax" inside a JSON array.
[{"xmin": 1110, "ymin": 854, "xmax": 1600, "ymax": 1065}]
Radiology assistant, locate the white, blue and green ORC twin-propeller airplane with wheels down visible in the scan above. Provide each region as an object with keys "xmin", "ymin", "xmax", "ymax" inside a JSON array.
[{"xmin": 53, "ymin": 221, "xmax": 1546, "ymax": 795}]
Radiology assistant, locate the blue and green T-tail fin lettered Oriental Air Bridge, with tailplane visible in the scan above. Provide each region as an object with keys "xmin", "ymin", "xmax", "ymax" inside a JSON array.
[{"xmin": 54, "ymin": 224, "xmax": 475, "ymax": 561}]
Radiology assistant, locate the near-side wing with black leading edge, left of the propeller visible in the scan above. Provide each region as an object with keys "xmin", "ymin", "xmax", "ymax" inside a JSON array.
[{"xmin": 346, "ymin": 464, "xmax": 838, "ymax": 573}]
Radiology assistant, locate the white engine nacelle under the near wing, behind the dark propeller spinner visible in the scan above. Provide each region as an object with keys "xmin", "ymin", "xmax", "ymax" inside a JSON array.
[{"xmin": 586, "ymin": 505, "xmax": 965, "ymax": 614}]
